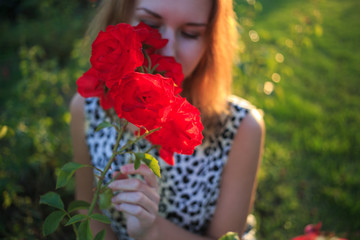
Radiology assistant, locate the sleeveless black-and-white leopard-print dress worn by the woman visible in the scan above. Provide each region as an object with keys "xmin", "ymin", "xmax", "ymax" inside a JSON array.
[{"xmin": 85, "ymin": 96, "xmax": 255, "ymax": 240}]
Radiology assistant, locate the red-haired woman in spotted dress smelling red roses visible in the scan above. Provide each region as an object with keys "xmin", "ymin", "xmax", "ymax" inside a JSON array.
[{"xmin": 71, "ymin": 0, "xmax": 265, "ymax": 240}]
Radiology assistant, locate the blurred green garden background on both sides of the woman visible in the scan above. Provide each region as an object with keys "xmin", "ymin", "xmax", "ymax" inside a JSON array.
[{"xmin": 0, "ymin": 0, "xmax": 360, "ymax": 239}]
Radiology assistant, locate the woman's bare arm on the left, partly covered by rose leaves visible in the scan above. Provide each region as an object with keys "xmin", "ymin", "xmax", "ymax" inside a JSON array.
[{"xmin": 70, "ymin": 94, "xmax": 116, "ymax": 240}]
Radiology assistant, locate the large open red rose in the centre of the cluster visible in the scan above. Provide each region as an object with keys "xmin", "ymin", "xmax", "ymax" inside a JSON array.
[{"xmin": 110, "ymin": 72, "xmax": 175, "ymax": 130}]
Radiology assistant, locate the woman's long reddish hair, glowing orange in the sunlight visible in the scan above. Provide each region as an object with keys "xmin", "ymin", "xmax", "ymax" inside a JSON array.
[{"xmin": 87, "ymin": 0, "xmax": 237, "ymax": 126}]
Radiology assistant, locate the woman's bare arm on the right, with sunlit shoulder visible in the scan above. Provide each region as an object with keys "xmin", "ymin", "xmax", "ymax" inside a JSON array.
[{"xmin": 208, "ymin": 109, "xmax": 265, "ymax": 238}]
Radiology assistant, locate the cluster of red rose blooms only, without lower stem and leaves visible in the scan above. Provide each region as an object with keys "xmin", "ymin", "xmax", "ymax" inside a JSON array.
[{"xmin": 77, "ymin": 23, "xmax": 203, "ymax": 165}]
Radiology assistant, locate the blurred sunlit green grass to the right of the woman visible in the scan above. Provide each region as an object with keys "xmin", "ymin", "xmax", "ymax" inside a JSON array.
[{"xmin": 236, "ymin": 0, "xmax": 360, "ymax": 239}]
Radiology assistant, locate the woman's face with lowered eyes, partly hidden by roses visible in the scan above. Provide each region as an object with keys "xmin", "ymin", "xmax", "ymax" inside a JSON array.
[{"xmin": 131, "ymin": 0, "xmax": 212, "ymax": 77}]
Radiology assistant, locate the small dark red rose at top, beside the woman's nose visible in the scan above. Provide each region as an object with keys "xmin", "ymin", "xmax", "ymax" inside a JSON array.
[{"xmin": 134, "ymin": 22, "xmax": 168, "ymax": 54}]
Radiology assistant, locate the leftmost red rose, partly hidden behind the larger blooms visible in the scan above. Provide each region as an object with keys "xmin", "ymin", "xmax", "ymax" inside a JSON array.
[{"xmin": 76, "ymin": 68, "xmax": 113, "ymax": 110}]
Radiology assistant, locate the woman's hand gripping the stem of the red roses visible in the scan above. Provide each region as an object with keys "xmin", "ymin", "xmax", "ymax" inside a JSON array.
[{"xmin": 109, "ymin": 164, "xmax": 160, "ymax": 239}]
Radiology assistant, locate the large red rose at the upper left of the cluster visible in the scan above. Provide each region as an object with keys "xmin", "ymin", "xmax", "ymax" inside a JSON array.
[{"xmin": 90, "ymin": 23, "xmax": 144, "ymax": 88}]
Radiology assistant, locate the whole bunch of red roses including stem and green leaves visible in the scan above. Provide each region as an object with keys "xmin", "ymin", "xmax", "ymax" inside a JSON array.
[{"xmin": 40, "ymin": 23, "xmax": 203, "ymax": 239}]
